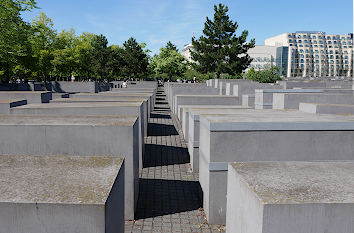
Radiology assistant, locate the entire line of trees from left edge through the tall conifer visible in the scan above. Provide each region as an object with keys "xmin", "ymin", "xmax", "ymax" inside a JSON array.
[{"xmin": 0, "ymin": 0, "xmax": 280, "ymax": 82}]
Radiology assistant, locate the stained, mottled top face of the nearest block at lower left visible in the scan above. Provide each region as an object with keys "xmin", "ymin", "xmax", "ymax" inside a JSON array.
[{"xmin": 0, "ymin": 155, "xmax": 123, "ymax": 204}]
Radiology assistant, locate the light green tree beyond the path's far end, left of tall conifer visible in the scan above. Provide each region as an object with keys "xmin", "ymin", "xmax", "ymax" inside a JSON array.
[{"xmin": 150, "ymin": 41, "xmax": 187, "ymax": 80}]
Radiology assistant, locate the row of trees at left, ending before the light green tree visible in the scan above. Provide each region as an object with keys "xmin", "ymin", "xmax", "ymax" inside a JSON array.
[{"xmin": 0, "ymin": 0, "xmax": 149, "ymax": 82}]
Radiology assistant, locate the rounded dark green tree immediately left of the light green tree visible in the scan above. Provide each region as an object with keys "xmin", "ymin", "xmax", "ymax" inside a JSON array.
[{"xmin": 122, "ymin": 37, "xmax": 149, "ymax": 79}]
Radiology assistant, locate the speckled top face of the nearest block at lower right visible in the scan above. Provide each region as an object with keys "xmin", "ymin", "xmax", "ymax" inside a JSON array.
[{"xmin": 230, "ymin": 161, "xmax": 354, "ymax": 204}]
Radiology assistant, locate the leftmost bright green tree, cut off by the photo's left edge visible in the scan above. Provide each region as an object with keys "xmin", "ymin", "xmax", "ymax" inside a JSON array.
[{"xmin": 0, "ymin": 0, "xmax": 36, "ymax": 82}]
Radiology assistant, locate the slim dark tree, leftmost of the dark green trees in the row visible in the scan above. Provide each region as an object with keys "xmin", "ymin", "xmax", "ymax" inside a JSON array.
[{"xmin": 91, "ymin": 34, "xmax": 109, "ymax": 80}]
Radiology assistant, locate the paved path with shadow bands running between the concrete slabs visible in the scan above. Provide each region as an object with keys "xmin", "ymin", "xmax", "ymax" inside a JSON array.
[{"xmin": 125, "ymin": 88, "xmax": 223, "ymax": 233}]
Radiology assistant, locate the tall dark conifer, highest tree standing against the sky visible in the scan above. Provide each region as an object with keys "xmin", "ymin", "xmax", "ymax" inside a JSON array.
[{"xmin": 190, "ymin": 4, "xmax": 255, "ymax": 78}]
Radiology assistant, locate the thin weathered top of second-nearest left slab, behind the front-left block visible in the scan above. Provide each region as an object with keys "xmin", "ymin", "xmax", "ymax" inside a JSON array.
[{"xmin": 0, "ymin": 115, "xmax": 137, "ymax": 126}]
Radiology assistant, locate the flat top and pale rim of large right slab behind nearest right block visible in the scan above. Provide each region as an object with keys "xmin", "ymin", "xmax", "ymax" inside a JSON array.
[{"xmin": 200, "ymin": 109, "xmax": 354, "ymax": 131}]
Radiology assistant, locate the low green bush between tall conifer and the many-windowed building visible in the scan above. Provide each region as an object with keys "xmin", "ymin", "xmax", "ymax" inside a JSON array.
[{"xmin": 246, "ymin": 67, "xmax": 281, "ymax": 83}]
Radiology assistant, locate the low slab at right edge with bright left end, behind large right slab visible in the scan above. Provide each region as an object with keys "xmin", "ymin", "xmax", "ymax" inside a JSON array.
[{"xmin": 299, "ymin": 103, "xmax": 354, "ymax": 115}]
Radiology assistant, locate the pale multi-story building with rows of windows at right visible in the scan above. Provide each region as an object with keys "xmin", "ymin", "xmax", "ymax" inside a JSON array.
[{"xmin": 265, "ymin": 31, "xmax": 353, "ymax": 77}]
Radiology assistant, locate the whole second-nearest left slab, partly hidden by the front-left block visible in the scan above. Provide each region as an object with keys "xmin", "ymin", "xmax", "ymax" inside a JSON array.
[{"xmin": 0, "ymin": 115, "xmax": 139, "ymax": 219}]
